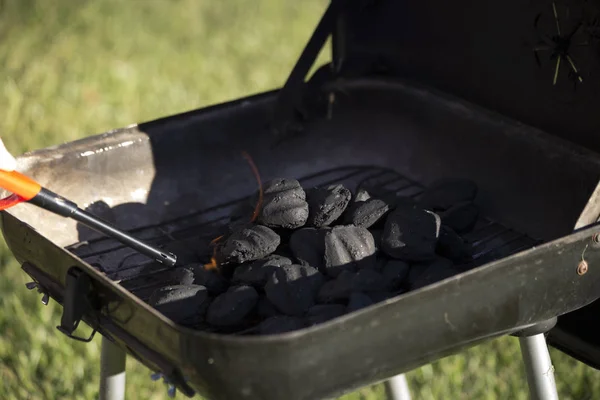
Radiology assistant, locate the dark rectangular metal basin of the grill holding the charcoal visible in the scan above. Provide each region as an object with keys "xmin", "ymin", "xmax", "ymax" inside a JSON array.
[{"xmin": 1, "ymin": 79, "xmax": 600, "ymax": 399}]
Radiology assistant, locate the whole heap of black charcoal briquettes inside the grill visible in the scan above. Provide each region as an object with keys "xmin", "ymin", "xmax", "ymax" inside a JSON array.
[{"xmin": 149, "ymin": 179, "xmax": 479, "ymax": 335}]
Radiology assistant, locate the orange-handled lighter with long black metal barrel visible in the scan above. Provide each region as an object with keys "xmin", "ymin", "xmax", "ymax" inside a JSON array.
[{"xmin": 0, "ymin": 170, "xmax": 177, "ymax": 266}]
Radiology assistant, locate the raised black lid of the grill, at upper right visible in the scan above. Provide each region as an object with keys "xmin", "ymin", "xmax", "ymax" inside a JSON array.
[{"xmin": 314, "ymin": 0, "xmax": 600, "ymax": 368}]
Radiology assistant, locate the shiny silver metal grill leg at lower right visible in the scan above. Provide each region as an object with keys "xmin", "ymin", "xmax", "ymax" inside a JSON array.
[{"xmin": 519, "ymin": 333, "xmax": 558, "ymax": 400}]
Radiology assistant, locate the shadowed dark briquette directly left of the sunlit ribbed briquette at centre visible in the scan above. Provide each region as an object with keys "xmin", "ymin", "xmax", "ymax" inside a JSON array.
[{"xmin": 289, "ymin": 228, "xmax": 329, "ymax": 271}]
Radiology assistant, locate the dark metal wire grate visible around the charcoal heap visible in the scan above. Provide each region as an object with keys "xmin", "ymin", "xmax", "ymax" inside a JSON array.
[{"xmin": 68, "ymin": 167, "xmax": 539, "ymax": 300}]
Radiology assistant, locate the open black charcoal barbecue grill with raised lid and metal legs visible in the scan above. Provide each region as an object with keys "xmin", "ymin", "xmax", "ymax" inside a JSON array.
[{"xmin": 1, "ymin": 0, "xmax": 600, "ymax": 400}]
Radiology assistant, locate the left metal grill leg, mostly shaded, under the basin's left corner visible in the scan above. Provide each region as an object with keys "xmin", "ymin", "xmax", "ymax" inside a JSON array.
[{"xmin": 100, "ymin": 336, "xmax": 126, "ymax": 400}]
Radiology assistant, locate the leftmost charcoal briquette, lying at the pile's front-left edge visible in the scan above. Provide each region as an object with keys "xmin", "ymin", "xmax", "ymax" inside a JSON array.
[{"xmin": 148, "ymin": 285, "xmax": 210, "ymax": 325}]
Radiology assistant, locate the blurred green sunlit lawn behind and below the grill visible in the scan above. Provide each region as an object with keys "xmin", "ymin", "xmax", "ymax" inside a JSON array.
[{"xmin": 0, "ymin": 0, "xmax": 600, "ymax": 400}]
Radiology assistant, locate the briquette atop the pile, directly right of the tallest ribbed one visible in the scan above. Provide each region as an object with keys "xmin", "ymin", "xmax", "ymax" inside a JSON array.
[{"xmin": 307, "ymin": 185, "xmax": 352, "ymax": 228}]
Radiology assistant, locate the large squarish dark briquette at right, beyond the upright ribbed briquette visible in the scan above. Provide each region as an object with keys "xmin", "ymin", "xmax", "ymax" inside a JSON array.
[{"xmin": 381, "ymin": 207, "xmax": 441, "ymax": 261}]
